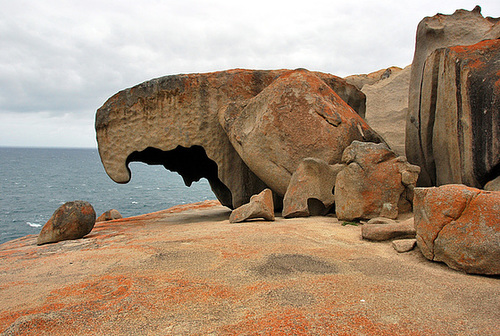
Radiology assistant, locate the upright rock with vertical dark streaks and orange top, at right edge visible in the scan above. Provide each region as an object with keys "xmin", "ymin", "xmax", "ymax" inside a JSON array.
[{"xmin": 410, "ymin": 40, "xmax": 500, "ymax": 188}]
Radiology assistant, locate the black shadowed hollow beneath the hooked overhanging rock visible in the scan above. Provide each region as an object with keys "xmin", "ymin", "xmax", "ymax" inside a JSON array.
[{"xmin": 127, "ymin": 146, "xmax": 232, "ymax": 208}]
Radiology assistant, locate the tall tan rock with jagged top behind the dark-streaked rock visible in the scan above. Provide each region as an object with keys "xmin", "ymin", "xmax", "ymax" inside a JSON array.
[{"xmin": 406, "ymin": 6, "xmax": 500, "ymax": 186}]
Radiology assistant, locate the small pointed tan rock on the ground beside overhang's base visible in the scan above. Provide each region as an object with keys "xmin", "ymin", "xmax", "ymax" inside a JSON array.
[{"xmin": 229, "ymin": 189, "xmax": 274, "ymax": 223}]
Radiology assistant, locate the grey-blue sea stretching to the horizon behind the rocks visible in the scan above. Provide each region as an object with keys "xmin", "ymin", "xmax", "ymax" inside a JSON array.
[{"xmin": 0, "ymin": 147, "xmax": 216, "ymax": 244}]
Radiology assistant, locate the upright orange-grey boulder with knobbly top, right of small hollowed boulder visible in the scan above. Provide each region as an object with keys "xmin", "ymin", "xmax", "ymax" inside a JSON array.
[{"xmin": 334, "ymin": 141, "xmax": 420, "ymax": 221}]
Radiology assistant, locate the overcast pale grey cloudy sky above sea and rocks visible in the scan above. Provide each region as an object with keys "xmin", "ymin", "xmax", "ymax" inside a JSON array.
[{"xmin": 0, "ymin": 0, "xmax": 500, "ymax": 148}]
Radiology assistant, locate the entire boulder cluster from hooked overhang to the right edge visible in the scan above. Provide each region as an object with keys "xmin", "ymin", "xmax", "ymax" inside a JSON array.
[{"xmin": 95, "ymin": 7, "xmax": 500, "ymax": 274}]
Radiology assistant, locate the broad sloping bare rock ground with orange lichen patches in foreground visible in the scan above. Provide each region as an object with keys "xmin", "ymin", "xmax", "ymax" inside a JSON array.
[{"xmin": 0, "ymin": 201, "xmax": 500, "ymax": 335}]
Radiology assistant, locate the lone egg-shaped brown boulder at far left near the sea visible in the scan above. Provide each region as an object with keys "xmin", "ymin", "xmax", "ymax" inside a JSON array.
[{"xmin": 37, "ymin": 201, "xmax": 96, "ymax": 245}]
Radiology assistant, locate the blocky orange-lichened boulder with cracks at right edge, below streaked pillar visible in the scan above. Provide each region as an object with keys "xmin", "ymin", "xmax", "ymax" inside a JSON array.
[{"xmin": 414, "ymin": 185, "xmax": 500, "ymax": 274}]
